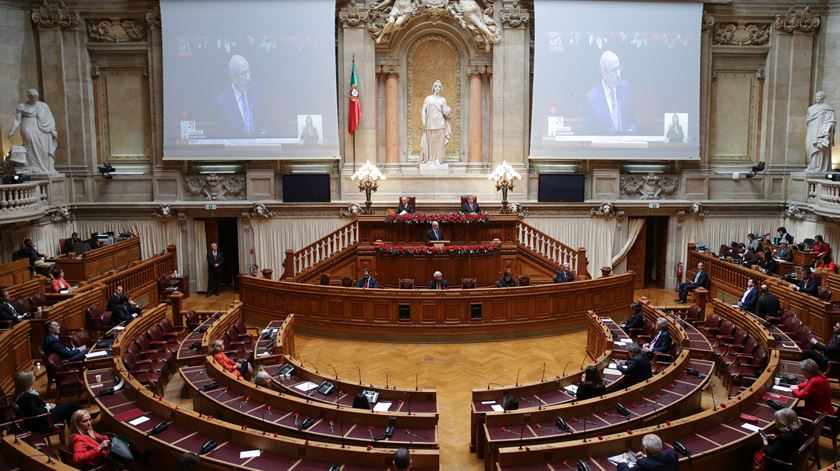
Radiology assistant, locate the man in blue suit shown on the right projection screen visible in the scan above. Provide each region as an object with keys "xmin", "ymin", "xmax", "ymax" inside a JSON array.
[{"xmin": 583, "ymin": 51, "xmax": 636, "ymax": 135}]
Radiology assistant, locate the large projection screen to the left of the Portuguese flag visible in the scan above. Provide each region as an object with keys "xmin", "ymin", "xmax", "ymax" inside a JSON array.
[{"xmin": 161, "ymin": 0, "xmax": 339, "ymax": 161}]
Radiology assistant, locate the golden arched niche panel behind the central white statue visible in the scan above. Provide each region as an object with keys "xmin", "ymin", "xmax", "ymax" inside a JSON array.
[{"xmin": 406, "ymin": 35, "xmax": 463, "ymax": 161}]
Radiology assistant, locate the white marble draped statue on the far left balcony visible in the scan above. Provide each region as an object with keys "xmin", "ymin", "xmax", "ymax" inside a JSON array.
[{"xmin": 9, "ymin": 88, "xmax": 58, "ymax": 175}]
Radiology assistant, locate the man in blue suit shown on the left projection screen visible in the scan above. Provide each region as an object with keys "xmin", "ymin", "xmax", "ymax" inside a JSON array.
[{"xmin": 216, "ymin": 55, "xmax": 265, "ymax": 139}]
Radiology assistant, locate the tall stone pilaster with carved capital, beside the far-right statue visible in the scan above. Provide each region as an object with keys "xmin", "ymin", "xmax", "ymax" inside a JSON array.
[{"xmin": 762, "ymin": 7, "xmax": 820, "ymax": 171}]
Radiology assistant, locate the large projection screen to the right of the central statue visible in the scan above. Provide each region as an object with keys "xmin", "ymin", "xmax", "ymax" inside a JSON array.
[{"xmin": 530, "ymin": 0, "xmax": 703, "ymax": 160}]
